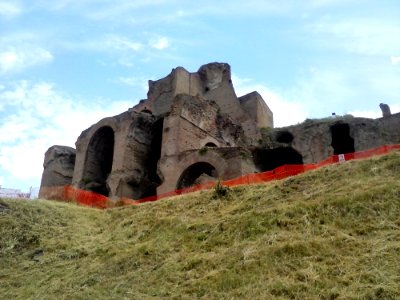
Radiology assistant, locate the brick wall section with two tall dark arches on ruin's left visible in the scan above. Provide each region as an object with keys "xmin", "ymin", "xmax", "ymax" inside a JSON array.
[{"xmin": 73, "ymin": 111, "xmax": 163, "ymax": 199}]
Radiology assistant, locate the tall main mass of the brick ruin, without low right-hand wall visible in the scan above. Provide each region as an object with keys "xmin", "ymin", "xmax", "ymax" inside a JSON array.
[{"xmin": 40, "ymin": 63, "xmax": 273, "ymax": 199}]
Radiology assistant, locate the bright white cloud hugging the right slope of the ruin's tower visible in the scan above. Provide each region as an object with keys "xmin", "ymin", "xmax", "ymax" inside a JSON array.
[{"xmin": 232, "ymin": 75, "xmax": 307, "ymax": 127}]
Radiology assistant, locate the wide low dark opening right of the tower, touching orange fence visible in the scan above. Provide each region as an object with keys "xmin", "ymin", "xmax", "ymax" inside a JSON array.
[{"xmin": 253, "ymin": 147, "xmax": 303, "ymax": 172}]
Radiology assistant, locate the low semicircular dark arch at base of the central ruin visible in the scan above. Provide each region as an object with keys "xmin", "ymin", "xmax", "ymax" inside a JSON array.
[{"xmin": 176, "ymin": 162, "xmax": 218, "ymax": 190}]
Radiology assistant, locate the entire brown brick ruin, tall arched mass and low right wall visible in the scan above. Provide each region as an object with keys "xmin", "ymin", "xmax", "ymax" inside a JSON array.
[{"xmin": 39, "ymin": 63, "xmax": 400, "ymax": 199}]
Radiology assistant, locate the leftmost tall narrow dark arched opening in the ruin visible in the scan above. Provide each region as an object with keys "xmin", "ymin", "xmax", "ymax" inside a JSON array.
[{"xmin": 82, "ymin": 126, "xmax": 114, "ymax": 196}]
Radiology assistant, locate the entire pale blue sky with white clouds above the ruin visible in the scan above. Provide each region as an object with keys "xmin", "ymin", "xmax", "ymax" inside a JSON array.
[{"xmin": 0, "ymin": 0, "xmax": 400, "ymax": 191}]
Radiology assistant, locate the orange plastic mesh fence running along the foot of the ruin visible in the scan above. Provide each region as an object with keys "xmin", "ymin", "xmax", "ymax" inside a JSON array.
[{"xmin": 41, "ymin": 145, "xmax": 400, "ymax": 209}]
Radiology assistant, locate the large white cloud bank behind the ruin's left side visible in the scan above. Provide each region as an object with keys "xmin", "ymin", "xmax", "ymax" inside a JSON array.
[{"xmin": 0, "ymin": 81, "xmax": 134, "ymax": 188}]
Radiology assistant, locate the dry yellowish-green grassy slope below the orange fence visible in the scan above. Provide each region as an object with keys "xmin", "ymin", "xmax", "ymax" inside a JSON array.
[{"xmin": 0, "ymin": 152, "xmax": 400, "ymax": 299}]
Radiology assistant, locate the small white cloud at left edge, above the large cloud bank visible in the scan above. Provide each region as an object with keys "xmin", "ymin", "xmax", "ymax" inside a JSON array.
[{"xmin": 0, "ymin": 46, "xmax": 53, "ymax": 73}]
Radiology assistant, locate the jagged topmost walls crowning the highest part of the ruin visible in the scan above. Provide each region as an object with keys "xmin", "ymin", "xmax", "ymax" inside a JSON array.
[{"xmin": 133, "ymin": 63, "xmax": 273, "ymax": 144}]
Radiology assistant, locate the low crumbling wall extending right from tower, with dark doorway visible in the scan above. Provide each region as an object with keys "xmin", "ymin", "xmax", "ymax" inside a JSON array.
[{"xmin": 261, "ymin": 114, "xmax": 400, "ymax": 163}]
